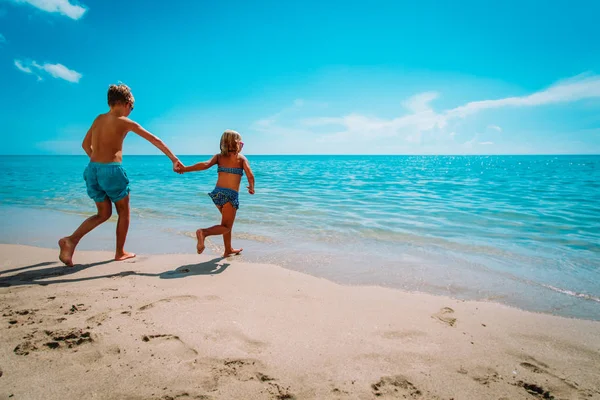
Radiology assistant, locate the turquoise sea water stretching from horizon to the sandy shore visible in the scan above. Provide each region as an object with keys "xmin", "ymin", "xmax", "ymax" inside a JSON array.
[{"xmin": 0, "ymin": 156, "xmax": 600, "ymax": 319}]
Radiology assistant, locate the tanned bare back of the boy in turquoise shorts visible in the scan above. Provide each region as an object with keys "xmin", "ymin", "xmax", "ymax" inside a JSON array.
[{"xmin": 88, "ymin": 112, "xmax": 133, "ymax": 163}]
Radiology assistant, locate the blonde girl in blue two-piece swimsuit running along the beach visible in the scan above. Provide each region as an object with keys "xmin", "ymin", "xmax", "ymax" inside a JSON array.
[{"xmin": 179, "ymin": 130, "xmax": 254, "ymax": 257}]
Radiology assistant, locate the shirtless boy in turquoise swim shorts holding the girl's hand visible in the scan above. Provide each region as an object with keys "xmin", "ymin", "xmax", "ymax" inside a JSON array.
[{"xmin": 58, "ymin": 84, "xmax": 182, "ymax": 267}]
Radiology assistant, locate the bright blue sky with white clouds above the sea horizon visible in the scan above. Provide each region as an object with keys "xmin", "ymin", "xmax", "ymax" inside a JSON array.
[{"xmin": 0, "ymin": 0, "xmax": 600, "ymax": 154}]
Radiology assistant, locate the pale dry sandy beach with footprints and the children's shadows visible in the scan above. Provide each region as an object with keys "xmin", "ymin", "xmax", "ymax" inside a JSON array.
[{"xmin": 0, "ymin": 245, "xmax": 600, "ymax": 400}]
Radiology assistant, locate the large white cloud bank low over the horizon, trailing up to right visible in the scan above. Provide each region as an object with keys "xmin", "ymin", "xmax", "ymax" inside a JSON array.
[{"xmin": 247, "ymin": 75, "xmax": 600, "ymax": 154}]
